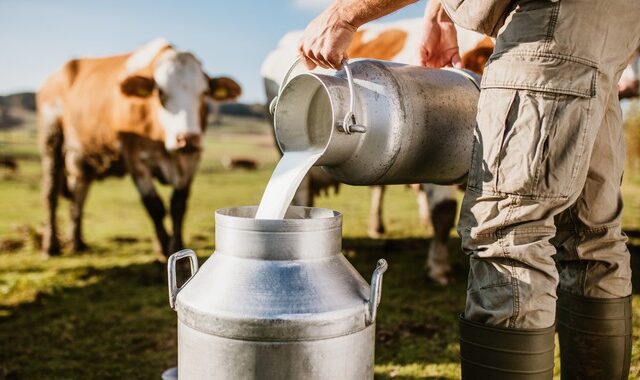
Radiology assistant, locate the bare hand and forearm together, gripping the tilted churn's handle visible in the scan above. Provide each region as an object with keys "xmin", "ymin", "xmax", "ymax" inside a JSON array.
[{"xmin": 298, "ymin": 0, "xmax": 420, "ymax": 70}]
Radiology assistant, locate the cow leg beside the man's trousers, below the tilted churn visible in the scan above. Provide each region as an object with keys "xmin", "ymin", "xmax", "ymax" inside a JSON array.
[{"xmin": 425, "ymin": 185, "xmax": 458, "ymax": 285}]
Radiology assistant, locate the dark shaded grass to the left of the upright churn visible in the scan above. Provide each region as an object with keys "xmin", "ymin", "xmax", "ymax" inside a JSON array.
[{"xmin": 0, "ymin": 264, "xmax": 176, "ymax": 379}]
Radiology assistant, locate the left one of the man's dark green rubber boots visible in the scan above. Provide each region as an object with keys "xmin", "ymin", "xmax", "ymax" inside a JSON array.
[{"xmin": 460, "ymin": 316, "xmax": 555, "ymax": 380}]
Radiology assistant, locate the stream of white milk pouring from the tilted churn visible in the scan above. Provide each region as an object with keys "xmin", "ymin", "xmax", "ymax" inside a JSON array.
[{"xmin": 256, "ymin": 150, "xmax": 322, "ymax": 219}]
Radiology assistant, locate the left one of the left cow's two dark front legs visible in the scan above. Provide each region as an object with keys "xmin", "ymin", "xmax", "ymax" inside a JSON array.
[{"xmin": 133, "ymin": 171, "xmax": 171, "ymax": 260}]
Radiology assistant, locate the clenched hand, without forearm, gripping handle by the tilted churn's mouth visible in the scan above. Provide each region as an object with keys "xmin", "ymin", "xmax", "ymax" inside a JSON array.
[{"xmin": 298, "ymin": 4, "xmax": 357, "ymax": 70}]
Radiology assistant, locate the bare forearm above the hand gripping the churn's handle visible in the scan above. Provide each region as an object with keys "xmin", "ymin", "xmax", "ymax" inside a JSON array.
[{"xmin": 330, "ymin": 0, "xmax": 420, "ymax": 28}]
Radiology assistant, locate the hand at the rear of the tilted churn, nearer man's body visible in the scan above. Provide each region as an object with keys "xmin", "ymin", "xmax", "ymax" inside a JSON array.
[{"xmin": 420, "ymin": 0, "xmax": 462, "ymax": 68}]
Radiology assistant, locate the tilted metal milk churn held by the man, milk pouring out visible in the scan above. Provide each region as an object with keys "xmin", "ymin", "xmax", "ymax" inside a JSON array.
[{"xmin": 270, "ymin": 59, "xmax": 480, "ymax": 185}]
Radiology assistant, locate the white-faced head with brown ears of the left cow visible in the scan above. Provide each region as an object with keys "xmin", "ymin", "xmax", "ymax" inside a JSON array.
[{"xmin": 120, "ymin": 47, "xmax": 241, "ymax": 151}]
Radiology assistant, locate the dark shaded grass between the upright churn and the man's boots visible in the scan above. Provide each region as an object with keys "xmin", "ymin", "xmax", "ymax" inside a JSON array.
[{"xmin": 343, "ymin": 238, "xmax": 467, "ymax": 379}]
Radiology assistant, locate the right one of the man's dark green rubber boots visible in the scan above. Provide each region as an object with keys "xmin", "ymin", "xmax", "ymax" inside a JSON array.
[{"xmin": 556, "ymin": 291, "xmax": 631, "ymax": 380}]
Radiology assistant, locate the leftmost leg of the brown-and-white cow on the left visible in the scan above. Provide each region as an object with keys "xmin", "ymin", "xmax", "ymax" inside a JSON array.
[{"xmin": 40, "ymin": 125, "xmax": 64, "ymax": 256}]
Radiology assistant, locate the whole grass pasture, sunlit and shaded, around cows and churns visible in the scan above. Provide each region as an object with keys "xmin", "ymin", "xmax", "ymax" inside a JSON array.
[{"xmin": 0, "ymin": 114, "xmax": 640, "ymax": 379}]
